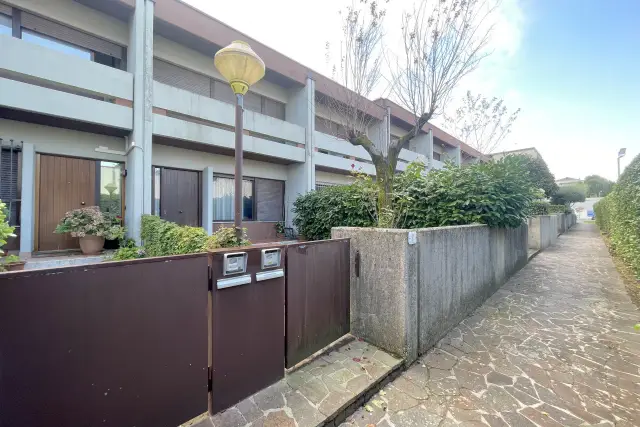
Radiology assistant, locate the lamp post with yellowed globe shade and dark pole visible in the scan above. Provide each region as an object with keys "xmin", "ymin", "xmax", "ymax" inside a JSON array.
[{"xmin": 213, "ymin": 40, "xmax": 265, "ymax": 241}]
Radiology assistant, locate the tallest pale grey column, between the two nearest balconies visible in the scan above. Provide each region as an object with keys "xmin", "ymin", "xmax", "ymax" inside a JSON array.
[{"xmin": 125, "ymin": 0, "xmax": 154, "ymax": 243}]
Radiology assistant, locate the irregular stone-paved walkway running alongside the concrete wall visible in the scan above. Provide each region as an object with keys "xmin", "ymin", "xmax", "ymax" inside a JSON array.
[{"xmin": 342, "ymin": 224, "xmax": 640, "ymax": 427}]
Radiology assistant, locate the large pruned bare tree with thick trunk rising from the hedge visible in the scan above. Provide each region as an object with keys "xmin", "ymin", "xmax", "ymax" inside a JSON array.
[{"xmin": 322, "ymin": 0, "xmax": 495, "ymax": 227}]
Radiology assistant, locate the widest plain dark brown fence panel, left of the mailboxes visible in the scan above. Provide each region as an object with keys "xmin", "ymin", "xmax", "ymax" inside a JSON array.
[{"xmin": 0, "ymin": 254, "xmax": 208, "ymax": 427}]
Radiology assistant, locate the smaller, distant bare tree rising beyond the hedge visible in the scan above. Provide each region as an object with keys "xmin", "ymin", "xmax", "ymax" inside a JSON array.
[{"xmin": 444, "ymin": 91, "xmax": 520, "ymax": 154}]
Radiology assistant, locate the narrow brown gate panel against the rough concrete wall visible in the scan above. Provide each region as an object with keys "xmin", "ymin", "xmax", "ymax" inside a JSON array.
[{"xmin": 286, "ymin": 239, "xmax": 350, "ymax": 368}]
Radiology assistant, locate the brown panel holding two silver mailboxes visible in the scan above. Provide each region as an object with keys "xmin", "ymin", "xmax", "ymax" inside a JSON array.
[{"xmin": 211, "ymin": 247, "xmax": 285, "ymax": 413}]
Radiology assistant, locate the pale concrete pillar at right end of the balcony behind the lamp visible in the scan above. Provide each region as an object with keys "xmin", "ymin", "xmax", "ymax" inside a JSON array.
[{"xmin": 285, "ymin": 77, "xmax": 316, "ymax": 227}]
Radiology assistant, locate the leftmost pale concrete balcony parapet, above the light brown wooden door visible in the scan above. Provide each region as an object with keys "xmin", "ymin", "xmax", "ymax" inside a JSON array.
[{"xmin": 0, "ymin": 35, "xmax": 133, "ymax": 130}]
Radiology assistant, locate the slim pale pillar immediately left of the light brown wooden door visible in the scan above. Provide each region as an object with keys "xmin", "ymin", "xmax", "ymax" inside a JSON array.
[{"xmin": 20, "ymin": 142, "xmax": 36, "ymax": 257}]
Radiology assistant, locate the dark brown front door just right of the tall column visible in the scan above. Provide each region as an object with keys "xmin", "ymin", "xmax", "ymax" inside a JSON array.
[{"xmin": 160, "ymin": 168, "xmax": 202, "ymax": 227}]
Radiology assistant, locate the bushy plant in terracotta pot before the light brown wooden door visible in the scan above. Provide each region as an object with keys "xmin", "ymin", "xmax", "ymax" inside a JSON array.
[{"xmin": 55, "ymin": 206, "xmax": 124, "ymax": 255}]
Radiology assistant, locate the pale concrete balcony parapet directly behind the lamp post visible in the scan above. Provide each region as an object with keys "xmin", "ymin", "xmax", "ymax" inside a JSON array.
[{"xmin": 153, "ymin": 82, "xmax": 306, "ymax": 163}]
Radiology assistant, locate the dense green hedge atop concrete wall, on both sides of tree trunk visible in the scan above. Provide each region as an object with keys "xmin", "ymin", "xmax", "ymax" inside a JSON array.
[{"xmin": 294, "ymin": 156, "xmax": 540, "ymax": 240}]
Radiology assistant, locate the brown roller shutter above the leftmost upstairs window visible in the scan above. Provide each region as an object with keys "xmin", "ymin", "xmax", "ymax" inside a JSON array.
[{"xmin": 22, "ymin": 12, "xmax": 124, "ymax": 59}]
